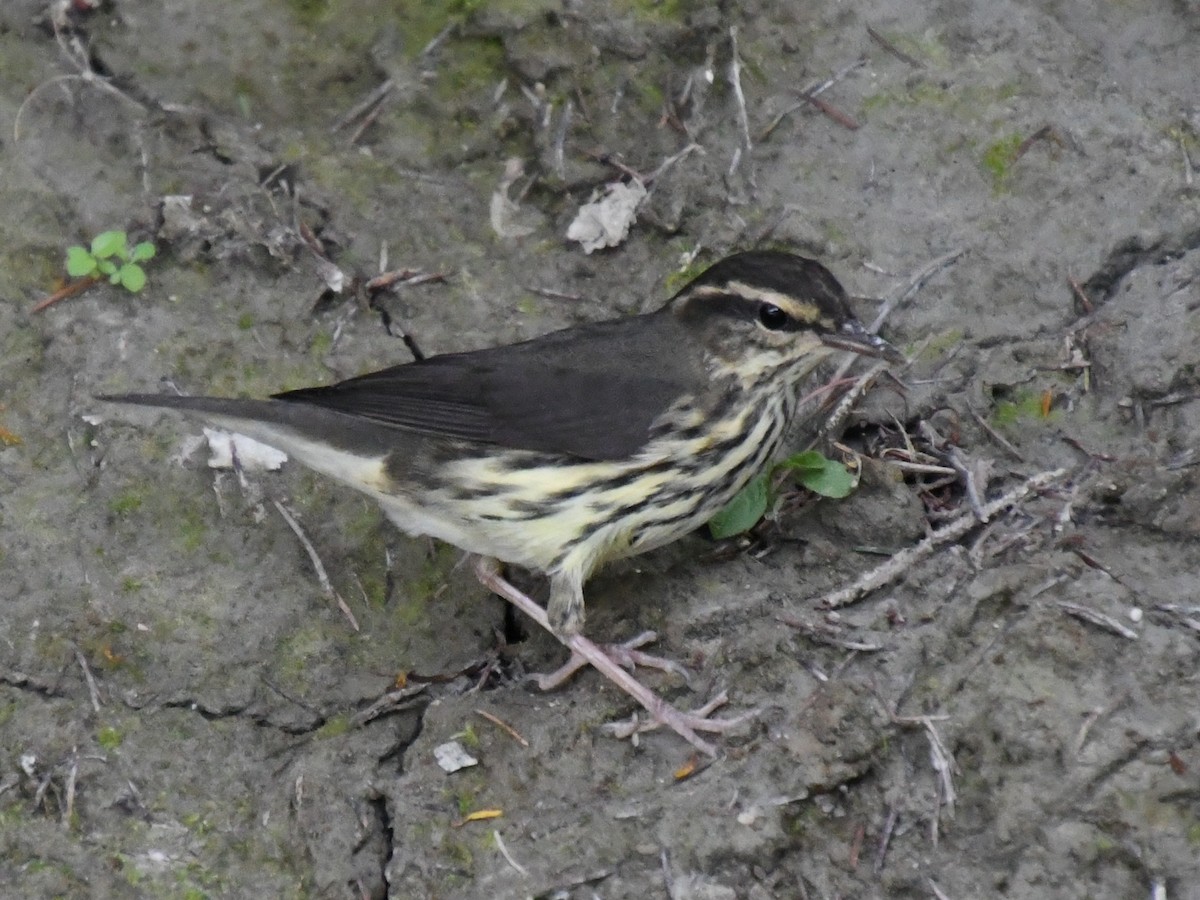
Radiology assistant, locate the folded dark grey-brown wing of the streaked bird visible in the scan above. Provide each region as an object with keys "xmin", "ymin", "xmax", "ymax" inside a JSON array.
[{"xmin": 275, "ymin": 313, "xmax": 704, "ymax": 460}]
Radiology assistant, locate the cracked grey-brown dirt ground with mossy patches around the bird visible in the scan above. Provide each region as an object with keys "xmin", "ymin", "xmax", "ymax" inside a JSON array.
[{"xmin": 0, "ymin": 0, "xmax": 1200, "ymax": 900}]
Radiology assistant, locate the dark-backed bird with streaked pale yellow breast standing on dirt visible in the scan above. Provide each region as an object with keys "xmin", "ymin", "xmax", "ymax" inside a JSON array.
[{"xmin": 97, "ymin": 250, "xmax": 904, "ymax": 756}]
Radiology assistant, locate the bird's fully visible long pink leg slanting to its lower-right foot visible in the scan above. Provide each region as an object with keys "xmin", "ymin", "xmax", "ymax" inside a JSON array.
[{"xmin": 475, "ymin": 557, "xmax": 745, "ymax": 756}]
